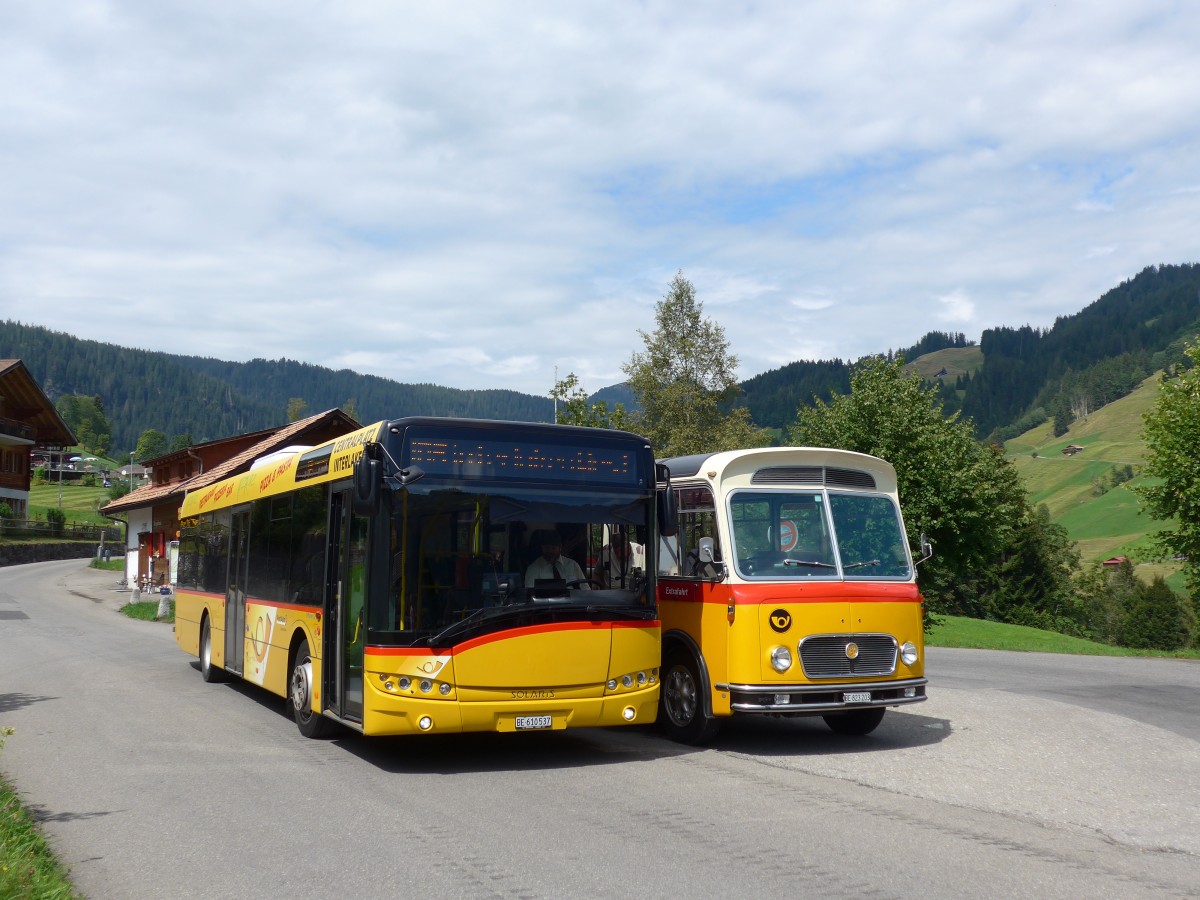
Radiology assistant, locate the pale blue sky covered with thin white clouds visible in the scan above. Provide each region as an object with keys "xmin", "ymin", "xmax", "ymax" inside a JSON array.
[{"xmin": 0, "ymin": 0, "xmax": 1200, "ymax": 395}]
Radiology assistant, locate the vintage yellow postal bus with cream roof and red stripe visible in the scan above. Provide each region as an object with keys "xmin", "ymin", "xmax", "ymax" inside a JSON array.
[{"xmin": 658, "ymin": 448, "xmax": 928, "ymax": 744}]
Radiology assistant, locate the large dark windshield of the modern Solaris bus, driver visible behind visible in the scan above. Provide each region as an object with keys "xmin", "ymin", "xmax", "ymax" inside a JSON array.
[{"xmin": 373, "ymin": 487, "xmax": 654, "ymax": 640}]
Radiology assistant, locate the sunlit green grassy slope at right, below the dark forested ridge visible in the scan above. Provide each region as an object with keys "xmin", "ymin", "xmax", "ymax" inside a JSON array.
[{"xmin": 1004, "ymin": 376, "xmax": 1182, "ymax": 590}]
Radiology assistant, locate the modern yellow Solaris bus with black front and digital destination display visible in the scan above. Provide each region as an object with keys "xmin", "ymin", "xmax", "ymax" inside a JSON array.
[{"xmin": 175, "ymin": 418, "xmax": 665, "ymax": 737}]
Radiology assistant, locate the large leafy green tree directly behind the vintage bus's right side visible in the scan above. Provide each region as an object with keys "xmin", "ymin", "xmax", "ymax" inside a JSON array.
[{"xmin": 791, "ymin": 356, "xmax": 1074, "ymax": 620}]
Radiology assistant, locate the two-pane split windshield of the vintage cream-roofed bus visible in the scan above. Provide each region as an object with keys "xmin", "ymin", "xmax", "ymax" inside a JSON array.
[{"xmin": 730, "ymin": 491, "xmax": 912, "ymax": 580}]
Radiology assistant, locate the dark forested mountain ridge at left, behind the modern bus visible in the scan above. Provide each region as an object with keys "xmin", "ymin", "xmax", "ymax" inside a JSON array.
[{"xmin": 0, "ymin": 320, "xmax": 553, "ymax": 456}]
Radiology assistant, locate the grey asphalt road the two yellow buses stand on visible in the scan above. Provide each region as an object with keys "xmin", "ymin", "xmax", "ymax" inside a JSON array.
[{"xmin": 0, "ymin": 560, "xmax": 1200, "ymax": 900}]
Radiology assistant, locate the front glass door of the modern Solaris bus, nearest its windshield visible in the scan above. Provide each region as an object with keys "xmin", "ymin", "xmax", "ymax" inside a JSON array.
[{"xmin": 323, "ymin": 490, "xmax": 370, "ymax": 722}]
